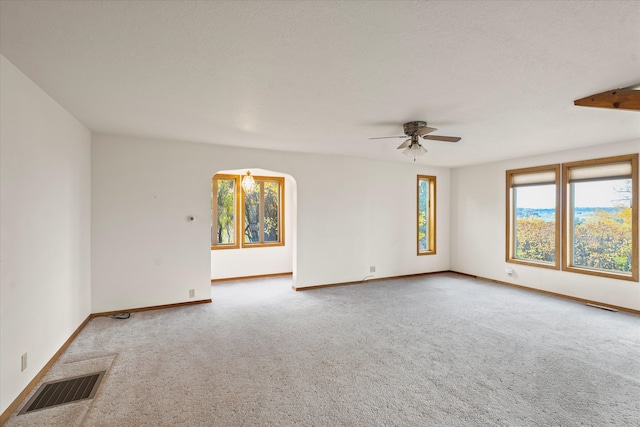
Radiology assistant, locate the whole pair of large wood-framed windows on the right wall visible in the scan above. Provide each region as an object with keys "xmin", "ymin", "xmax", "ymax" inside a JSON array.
[{"xmin": 506, "ymin": 154, "xmax": 639, "ymax": 282}]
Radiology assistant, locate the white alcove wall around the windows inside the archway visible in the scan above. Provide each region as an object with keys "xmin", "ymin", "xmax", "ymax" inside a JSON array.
[{"xmin": 211, "ymin": 168, "xmax": 297, "ymax": 280}]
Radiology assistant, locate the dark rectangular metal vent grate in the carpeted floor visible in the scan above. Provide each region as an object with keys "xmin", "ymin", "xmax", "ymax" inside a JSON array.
[{"xmin": 18, "ymin": 371, "xmax": 105, "ymax": 415}]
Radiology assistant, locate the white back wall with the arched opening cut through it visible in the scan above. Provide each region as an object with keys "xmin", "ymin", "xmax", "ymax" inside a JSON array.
[{"xmin": 92, "ymin": 135, "xmax": 449, "ymax": 312}]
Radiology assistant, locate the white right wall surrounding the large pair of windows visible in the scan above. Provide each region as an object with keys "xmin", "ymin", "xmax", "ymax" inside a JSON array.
[{"xmin": 451, "ymin": 140, "xmax": 640, "ymax": 310}]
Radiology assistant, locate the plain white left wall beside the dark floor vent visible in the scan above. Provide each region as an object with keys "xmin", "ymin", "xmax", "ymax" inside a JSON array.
[{"xmin": 0, "ymin": 55, "xmax": 91, "ymax": 412}]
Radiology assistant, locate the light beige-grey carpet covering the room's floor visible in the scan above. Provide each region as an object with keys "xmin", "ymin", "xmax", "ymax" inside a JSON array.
[{"xmin": 6, "ymin": 273, "xmax": 640, "ymax": 427}]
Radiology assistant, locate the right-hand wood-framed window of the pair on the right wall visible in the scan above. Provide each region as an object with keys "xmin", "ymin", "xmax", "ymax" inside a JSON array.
[{"xmin": 563, "ymin": 154, "xmax": 638, "ymax": 281}]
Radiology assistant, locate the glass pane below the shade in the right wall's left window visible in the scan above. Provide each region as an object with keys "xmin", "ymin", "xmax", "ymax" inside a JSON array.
[{"xmin": 513, "ymin": 185, "xmax": 556, "ymax": 264}]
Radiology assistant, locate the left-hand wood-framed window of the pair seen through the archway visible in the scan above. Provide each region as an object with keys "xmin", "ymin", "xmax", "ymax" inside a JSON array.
[{"xmin": 211, "ymin": 174, "xmax": 240, "ymax": 249}]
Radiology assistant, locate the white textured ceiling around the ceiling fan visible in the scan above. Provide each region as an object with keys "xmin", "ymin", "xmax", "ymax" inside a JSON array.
[{"xmin": 0, "ymin": 0, "xmax": 640, "ymax": 167}]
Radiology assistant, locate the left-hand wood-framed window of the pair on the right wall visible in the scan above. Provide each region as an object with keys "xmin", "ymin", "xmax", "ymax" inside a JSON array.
[{"xmin": 506, "ymin": 165, "xmax": 560, "ymax": 269}]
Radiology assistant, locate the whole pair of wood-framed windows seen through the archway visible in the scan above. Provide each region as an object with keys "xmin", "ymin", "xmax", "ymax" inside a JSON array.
[{"xmin": 211, "ymin": 174, "xmax": 284, "ymax": 249}]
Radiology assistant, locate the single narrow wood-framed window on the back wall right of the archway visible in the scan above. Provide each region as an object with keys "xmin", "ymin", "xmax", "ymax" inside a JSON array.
[{"xmin": 418, "ymin": 175, "xmax": 436, "ymax": 255}]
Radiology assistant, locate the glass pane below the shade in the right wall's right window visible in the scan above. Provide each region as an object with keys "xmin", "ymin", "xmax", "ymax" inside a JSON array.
[{"xmin": 571, "ymin": 179, "xmax": 633, "ymax": 273}]
